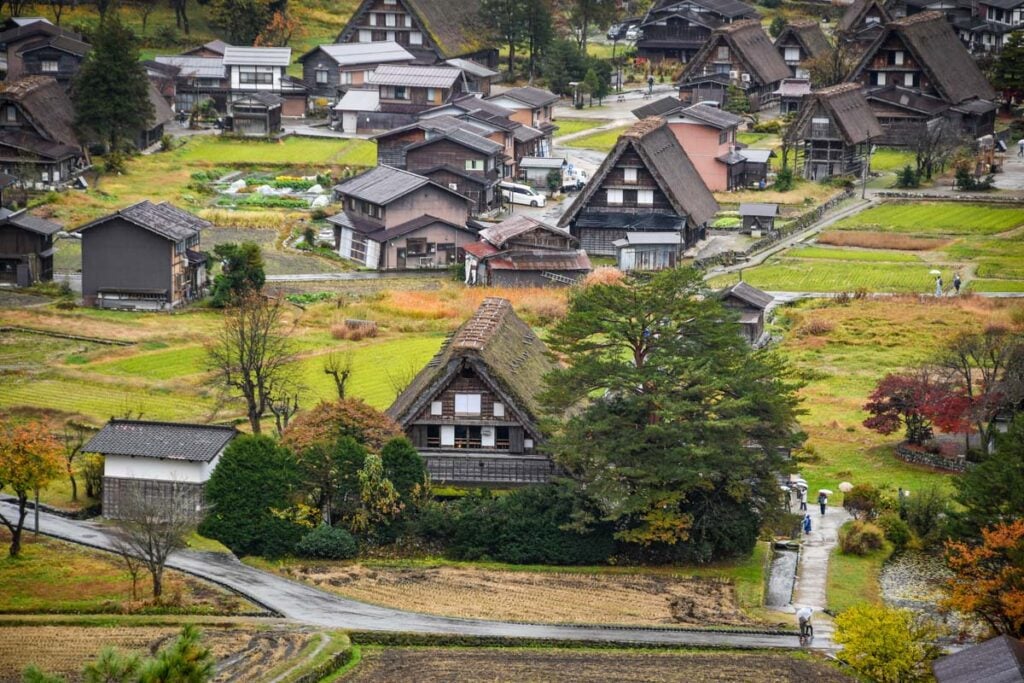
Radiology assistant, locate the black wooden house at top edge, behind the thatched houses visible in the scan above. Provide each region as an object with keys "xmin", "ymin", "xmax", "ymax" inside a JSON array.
[{"xmin": 636, "ymin": 0, "xmax": 758, "ymax": 62}]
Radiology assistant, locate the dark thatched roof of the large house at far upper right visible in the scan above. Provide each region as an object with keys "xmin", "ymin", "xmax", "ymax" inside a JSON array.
[{"xmin": 852, "ymin": 12, "xmax": 995, "ymax": 104}]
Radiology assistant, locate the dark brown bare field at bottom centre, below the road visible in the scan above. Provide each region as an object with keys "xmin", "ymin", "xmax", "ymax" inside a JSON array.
[{"xmin": 345, "ymin": 647, "xmax": 855, "ymax": 683}]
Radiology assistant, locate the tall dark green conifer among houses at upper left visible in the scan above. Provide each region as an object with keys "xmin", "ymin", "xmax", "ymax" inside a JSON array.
[{"xmin": 72, "ymin": 17, "xmax": 154, "ymax": 152}]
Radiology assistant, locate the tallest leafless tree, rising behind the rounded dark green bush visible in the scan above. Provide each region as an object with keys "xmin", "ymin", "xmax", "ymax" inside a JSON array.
[{"xmin": 207, "ymin": 292, "xmax": 294, "ymax": 434}]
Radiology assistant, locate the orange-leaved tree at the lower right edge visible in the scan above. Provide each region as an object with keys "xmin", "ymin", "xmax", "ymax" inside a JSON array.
[{"xmin": 945, "ymin": 519, "xmax": 1024, "ymax": 638}]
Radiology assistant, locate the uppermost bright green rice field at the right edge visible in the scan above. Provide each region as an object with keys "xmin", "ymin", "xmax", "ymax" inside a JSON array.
[{"xmin": 833, "ymin": 202, "xmax": 1024, "ymax": 234}]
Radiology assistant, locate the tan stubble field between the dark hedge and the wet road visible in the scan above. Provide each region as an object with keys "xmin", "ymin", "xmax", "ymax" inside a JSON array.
[{"xmin": 287, "ymin": 564, "xmax": 752, "ymax": 626}]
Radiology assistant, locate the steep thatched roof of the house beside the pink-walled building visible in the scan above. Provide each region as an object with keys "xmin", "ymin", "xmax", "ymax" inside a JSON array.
[{"xmin": 558, "ymin": 117, "xmax": 716, "ymax": 226}]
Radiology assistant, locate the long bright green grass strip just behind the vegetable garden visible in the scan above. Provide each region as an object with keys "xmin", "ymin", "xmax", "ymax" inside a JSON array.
[{"xmin": 176, "ymin": 135, "xmax": 377, "ymax": 166}]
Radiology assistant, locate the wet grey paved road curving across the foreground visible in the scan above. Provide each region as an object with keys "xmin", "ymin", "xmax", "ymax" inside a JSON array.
[{"xmin": 6, "ymin": 503, "xmax": 800, "ymax": 648}]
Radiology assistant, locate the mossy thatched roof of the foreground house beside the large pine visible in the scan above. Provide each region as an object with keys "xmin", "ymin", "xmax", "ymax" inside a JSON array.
[{"xmin": 387, "ymin": 297, "xmax": 557, "ymax": 439}]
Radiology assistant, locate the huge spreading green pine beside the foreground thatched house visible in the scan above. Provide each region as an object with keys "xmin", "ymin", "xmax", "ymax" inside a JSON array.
[{"xmin": 543, "ymin": 268, "xmax": 799, "ymax": 548}]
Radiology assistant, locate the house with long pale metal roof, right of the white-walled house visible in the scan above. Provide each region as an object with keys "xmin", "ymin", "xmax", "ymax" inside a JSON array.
[{"xmin": 299, "ymin": 42, "xmax": 416, "ymax": 100}]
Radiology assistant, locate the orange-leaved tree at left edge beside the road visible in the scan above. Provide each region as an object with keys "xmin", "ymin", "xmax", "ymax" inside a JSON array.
[{"xmin": 0, "ymin": 422, "xmax": 63, "ymax": 557}]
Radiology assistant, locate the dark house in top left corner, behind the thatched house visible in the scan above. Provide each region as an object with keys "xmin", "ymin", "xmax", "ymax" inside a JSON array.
[{"xmin": 0, "ymin": 16, "xmax": 89, "ymax": 89}]
